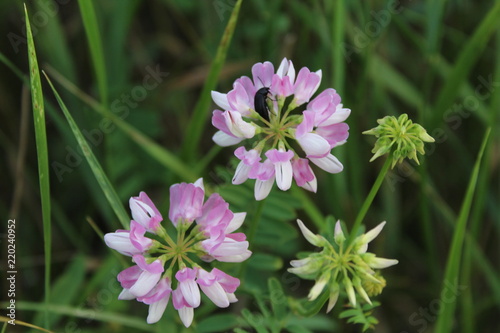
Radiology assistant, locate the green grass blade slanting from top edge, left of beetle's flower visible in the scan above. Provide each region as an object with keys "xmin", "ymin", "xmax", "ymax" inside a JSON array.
[{"xmin": 182, "ymin": 0, "xmax": 242, "ymax": 160}]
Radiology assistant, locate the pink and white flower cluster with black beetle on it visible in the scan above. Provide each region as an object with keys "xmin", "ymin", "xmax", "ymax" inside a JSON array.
[{"xmin": 212, "ymin": 58, "xmax": 351, "ymax": 200}]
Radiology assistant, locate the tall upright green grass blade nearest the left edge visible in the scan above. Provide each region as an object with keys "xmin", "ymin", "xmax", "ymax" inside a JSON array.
[{"xmin": 24, "ymin": 6, "xmax": 52, "ymax": 328}]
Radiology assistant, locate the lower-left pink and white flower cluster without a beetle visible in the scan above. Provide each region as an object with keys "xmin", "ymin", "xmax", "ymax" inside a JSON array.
[{"xmin": 104, "ymin": 179, "xmax": 251, "ymax": 327}]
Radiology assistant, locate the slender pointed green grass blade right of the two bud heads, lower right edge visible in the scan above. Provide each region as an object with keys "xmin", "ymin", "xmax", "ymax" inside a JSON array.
[{"xmin": 436, "ymin": 129, "xmax": 491, "ymax": 333}]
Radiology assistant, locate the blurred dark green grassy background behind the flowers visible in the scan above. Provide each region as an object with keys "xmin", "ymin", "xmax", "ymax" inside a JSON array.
[{"xmin": 0, "ymin": 0, "xmax": 500, "ymax": 333}]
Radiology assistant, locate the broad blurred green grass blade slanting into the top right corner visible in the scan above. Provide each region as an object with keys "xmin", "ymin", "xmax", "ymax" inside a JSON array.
[{"xmin": 434, "ymin": 1, "xmax": 500, "ymax": 121}]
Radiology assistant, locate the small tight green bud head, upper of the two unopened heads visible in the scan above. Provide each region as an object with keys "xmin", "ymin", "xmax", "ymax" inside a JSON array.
[{"xmin": 363, "ymin": 113, "xmax": 434, "ymax": 168}]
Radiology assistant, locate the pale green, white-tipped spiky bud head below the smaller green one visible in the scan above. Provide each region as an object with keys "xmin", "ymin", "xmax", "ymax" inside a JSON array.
[{"xmin": 288, "ymin": 220, "xmax": 398, "ymax": 312}]
